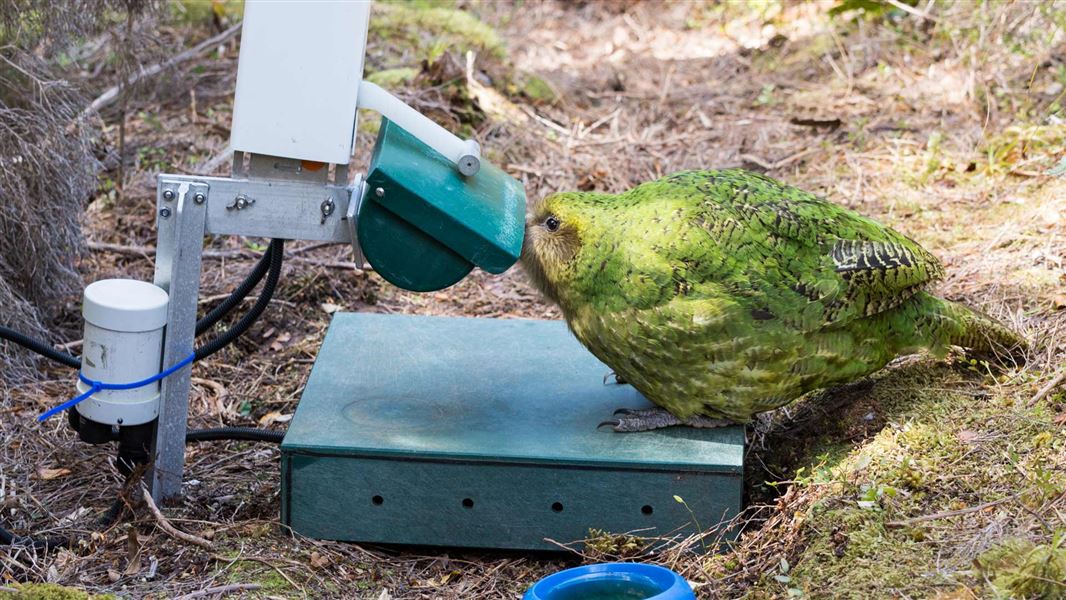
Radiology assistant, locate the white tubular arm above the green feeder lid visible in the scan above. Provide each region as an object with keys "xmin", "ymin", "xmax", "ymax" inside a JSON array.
[{"xmin": 358, "ymin": 81, "xmax": 481, "ymax": 177}]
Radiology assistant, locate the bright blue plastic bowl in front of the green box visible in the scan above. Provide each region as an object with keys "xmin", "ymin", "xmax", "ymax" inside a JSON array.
[{"xmin": 523, "ymin": 563, "xmax": 696, "ymax": 600}]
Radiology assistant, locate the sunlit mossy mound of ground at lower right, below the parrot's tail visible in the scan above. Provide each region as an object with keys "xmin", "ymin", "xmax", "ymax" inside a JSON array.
[{"xmin": 741, "ymin": 359, "xmax": 1066, "ymax": 598}]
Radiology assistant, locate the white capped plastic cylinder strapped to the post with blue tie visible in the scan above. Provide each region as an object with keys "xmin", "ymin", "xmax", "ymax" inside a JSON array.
[{"xmin": 78, "ymin": 279, "xmax": 169, "ymax": 425}]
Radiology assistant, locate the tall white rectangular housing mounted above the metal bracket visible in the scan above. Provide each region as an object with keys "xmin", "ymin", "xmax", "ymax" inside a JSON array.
[{"xmin": 230, "ymin": 0, "xmax": 370, "ymax": 164}]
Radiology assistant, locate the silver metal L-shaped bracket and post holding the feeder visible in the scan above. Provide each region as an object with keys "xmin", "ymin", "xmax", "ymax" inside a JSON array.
[{"xmin": 149, "ymin": 164, "xmax": 364, "ymax": 502}]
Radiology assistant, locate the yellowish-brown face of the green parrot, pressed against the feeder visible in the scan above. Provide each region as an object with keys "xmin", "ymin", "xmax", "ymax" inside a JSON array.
[{"xmin": 521, "ymin": 192, "xmax": 591, "ymax": 303}]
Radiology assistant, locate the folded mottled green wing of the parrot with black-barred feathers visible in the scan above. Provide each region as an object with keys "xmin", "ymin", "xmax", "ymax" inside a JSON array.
[{"xmin": 672, "ymin": 171, "xmax": 943, "ymax": 329}]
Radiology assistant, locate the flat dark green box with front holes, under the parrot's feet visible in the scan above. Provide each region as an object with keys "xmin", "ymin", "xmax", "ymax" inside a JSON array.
[{"xmin": 281, "ymin": 313, "xmax": 744, "ymax": 550}]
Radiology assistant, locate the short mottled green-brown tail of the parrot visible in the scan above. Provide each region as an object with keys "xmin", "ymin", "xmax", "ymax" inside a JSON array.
[{"xmin": 900, "ymin": 292, "xmax": 1029, "ymax": 360}]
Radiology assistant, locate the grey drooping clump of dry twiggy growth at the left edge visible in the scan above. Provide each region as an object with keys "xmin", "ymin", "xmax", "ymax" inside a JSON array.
[{"xmin": 0, "ymin": 46, "xmax": 98, "ymax": 385}]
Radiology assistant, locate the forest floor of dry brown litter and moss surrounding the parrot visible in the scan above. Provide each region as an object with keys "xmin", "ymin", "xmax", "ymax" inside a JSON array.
[{"xmin": 0, "ymin": 2, "xmax": 1066, "ymax": 599}]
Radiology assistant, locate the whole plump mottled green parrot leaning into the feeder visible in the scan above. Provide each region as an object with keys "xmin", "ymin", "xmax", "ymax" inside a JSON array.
[{"xmin": 521, "ymin": 169, "xmax": 1025, "ymax": 432}]
